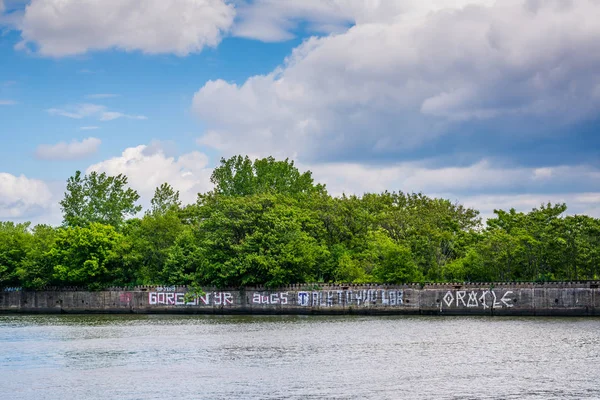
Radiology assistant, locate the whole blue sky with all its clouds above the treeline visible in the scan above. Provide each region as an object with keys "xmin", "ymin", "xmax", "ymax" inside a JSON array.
[{"xmin": 0, "ymin": 0, "xmax": 600, "ymax": 225}]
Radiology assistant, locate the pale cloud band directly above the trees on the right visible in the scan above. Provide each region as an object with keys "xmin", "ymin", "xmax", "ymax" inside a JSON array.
[{"xmin": 299, "ymin": 160, "xmax": 600, "ymax": 220}]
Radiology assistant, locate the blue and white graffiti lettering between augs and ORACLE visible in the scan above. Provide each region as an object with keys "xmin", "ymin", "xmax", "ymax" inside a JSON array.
[{"xmin": 298, "ymin": 289, "xmax": 404, "ymax": 307}]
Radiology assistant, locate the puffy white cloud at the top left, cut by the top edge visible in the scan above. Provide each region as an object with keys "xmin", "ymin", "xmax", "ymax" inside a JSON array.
[{"xmin": 20, "ymin": 0, "xmax": 235, "ymax": 57}]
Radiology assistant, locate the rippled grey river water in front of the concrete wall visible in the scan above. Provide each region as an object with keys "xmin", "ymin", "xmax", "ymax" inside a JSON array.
[{"xmin": 0, "ymin": 316, "xmax": 600, "ymax": 400}]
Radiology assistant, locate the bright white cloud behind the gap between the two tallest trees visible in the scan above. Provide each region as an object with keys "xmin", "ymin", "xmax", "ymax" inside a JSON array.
[{"xmin": 86, "ymin": 142, "xmax": 212, "ymax": 206}]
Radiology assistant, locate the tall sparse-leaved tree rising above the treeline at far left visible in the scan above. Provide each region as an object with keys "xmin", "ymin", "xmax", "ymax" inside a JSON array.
[{"xmin": 60, "ymin": 171, "xmax": 142, "ymax": 228}]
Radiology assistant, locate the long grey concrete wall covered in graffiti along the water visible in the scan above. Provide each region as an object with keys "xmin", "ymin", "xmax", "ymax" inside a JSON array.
[{"xmin": 0, "ymin": 282, "xmax": 600, "ymax": 316}]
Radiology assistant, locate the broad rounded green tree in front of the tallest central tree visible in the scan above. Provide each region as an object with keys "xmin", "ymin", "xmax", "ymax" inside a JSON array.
[{"xmin": 196, "ymin": 194, "xmax": 327, "ymax": 286}]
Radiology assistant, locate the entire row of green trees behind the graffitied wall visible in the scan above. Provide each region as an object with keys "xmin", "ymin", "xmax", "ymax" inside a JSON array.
[{"xmin": 0, "ymin": 156, "xmax": 600, "ymax": 289}]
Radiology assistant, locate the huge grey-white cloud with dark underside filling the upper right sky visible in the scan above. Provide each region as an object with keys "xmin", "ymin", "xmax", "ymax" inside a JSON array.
[{"xmin": 193, "ymin": 0, "xmax": 600, "ymax": 161}]
